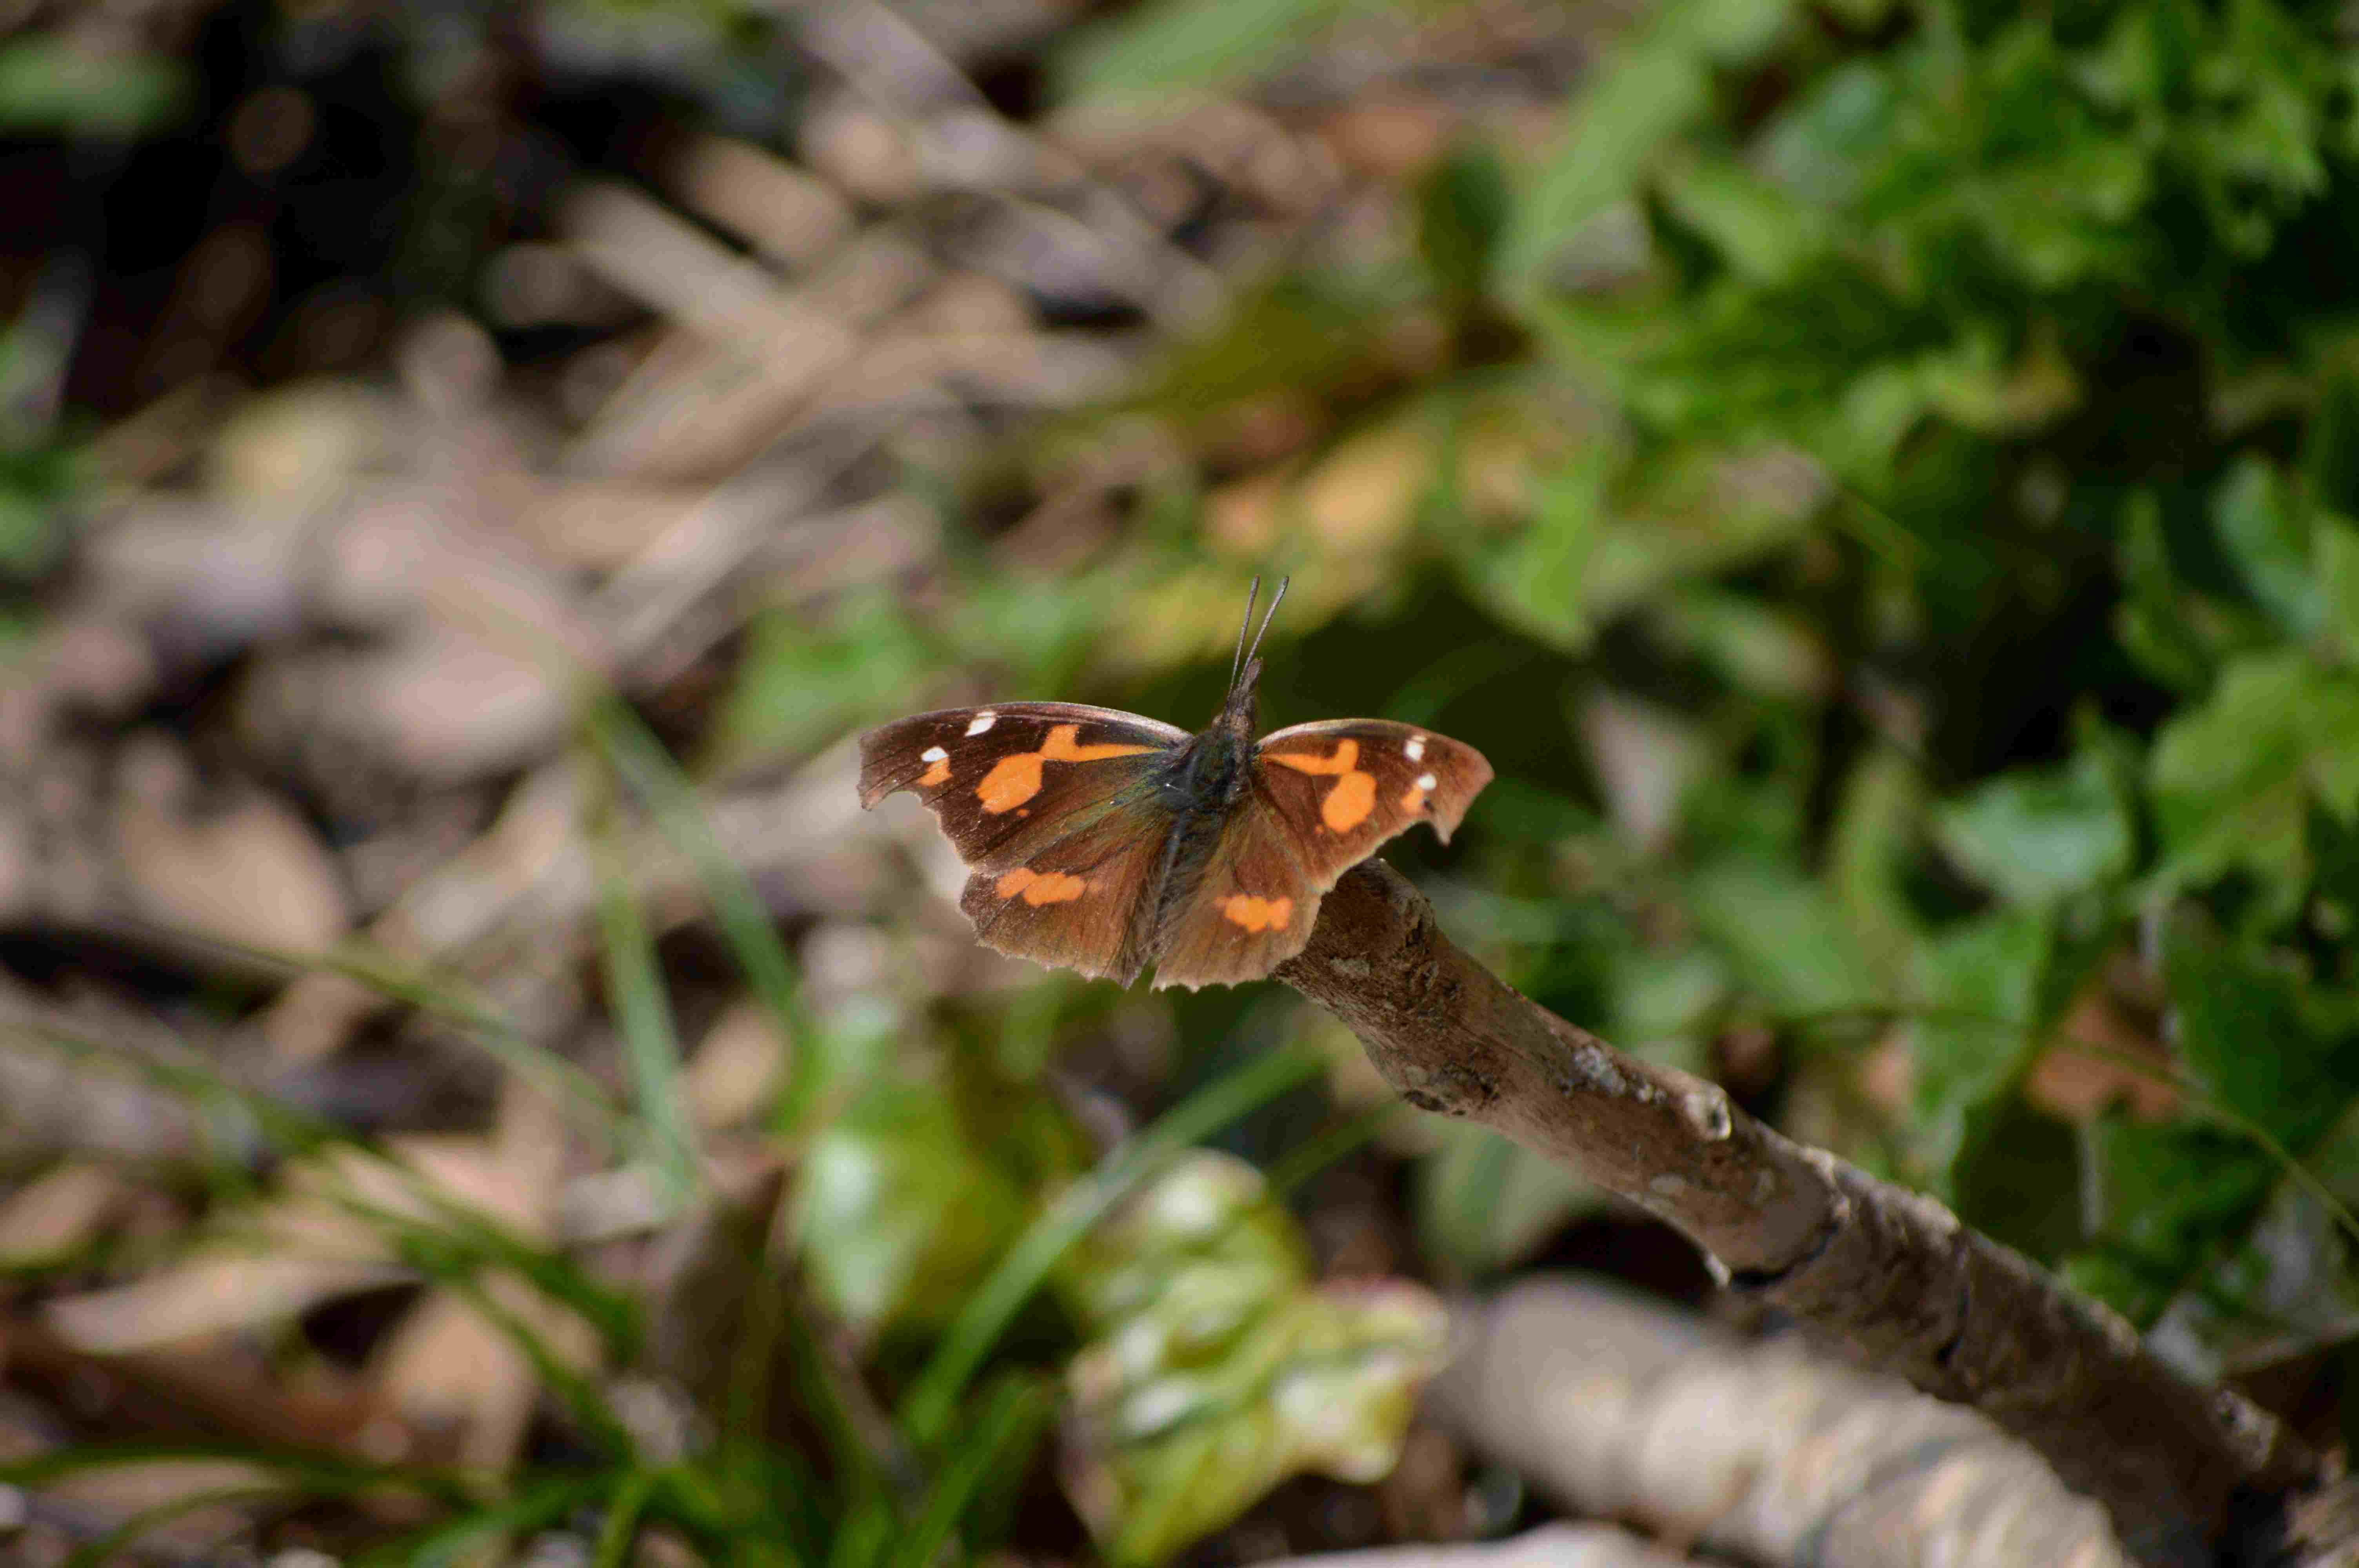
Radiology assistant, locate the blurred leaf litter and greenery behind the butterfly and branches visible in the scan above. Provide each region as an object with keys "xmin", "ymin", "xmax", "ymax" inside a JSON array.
[{"xmin": 0, "ymin": 0, "xmax": 2359, "ymax": 1568}]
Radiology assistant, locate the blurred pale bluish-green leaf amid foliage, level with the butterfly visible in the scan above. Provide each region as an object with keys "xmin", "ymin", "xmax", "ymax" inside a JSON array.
[{"xmin": 1934, "ymin": 750, "xmax": 2135, "ymax": 903}]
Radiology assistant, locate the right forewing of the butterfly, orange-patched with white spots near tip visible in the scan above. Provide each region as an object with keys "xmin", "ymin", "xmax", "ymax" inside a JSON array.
[{"xmin": 1255, "ymin": 719, "xmax": 1491, "ymax": 891}]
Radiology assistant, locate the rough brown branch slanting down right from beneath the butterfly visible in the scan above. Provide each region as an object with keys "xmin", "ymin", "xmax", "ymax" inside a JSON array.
[{"xmin": 1276, "ymin": 860, "xmax": 2319, "ymax": 1568}]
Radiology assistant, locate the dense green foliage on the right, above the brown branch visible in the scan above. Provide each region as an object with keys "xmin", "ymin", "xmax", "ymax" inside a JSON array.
[{"xmin": 1472, "ymin": 0, "xmax": 2359, "ymax": 1339}]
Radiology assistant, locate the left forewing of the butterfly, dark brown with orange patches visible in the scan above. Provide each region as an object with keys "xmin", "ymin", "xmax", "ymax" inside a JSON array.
[{"xmin": 861, "ymin": 702, "xmax": 1187, "ymax": 873}]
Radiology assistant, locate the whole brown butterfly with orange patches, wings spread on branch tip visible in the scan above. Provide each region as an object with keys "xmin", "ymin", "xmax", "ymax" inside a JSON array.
[{"xmin": 861, "ymin": 580, "xmax": 1491, "ymax": 990}]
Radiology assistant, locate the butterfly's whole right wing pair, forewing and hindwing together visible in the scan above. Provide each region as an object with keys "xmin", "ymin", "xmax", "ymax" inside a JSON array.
[{"xmin": 1156, "ymin": 719, "xmax": 1491, "ymax": 988}]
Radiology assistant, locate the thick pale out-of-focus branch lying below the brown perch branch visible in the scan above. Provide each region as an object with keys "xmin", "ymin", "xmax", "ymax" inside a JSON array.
[{"xmin": 1432, "ymin": 1276, "xmax": 2125, "ymax": 1568}]
